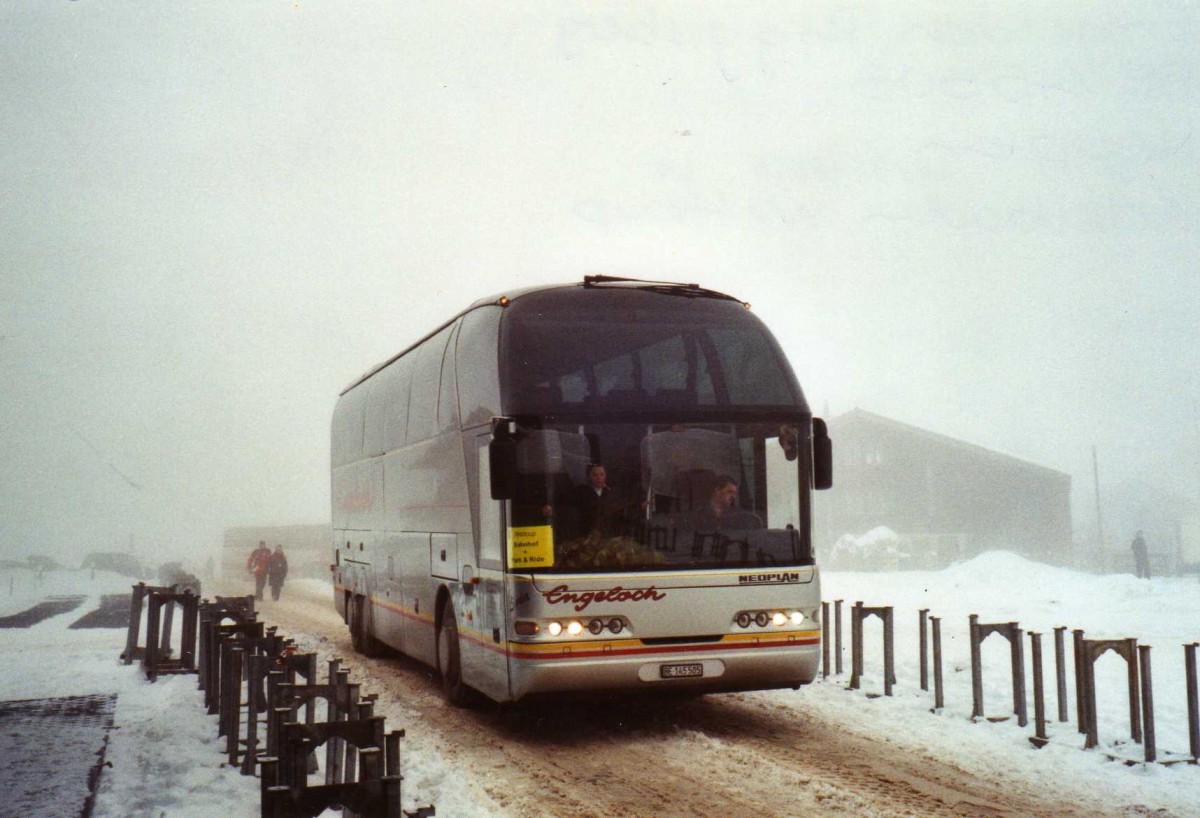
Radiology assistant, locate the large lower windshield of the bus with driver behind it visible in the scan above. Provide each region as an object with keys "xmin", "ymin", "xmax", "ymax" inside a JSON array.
[{"xmin": 510, "ymin": 420, "xmax": 812, "ymax": 572}]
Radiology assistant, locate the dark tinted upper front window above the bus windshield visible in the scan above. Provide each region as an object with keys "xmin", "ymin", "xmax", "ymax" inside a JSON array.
[{"xmin": 500, "ymin": 287, "xmax": 804, "ymax": 414}]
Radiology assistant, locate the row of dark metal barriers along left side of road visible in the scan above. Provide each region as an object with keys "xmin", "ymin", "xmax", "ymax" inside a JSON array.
[{"xmin": 113, "ymin": 592, "xmax": 436, "ymax": 818}]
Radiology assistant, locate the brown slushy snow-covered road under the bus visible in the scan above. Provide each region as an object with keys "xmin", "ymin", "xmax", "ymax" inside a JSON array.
[{"xmin": 226, "ymin": 573, "xmax": 1142, "ymax": 818}]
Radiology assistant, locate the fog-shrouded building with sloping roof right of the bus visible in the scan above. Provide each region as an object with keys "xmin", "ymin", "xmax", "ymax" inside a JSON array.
[{"xmin": 815, "ymin": 409, "xmax": 1072, "ymax": 567}]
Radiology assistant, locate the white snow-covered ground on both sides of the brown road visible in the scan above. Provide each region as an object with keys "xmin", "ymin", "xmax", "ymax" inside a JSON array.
[{"xmin": 0, "ymin": 552, "xmax": 1200, "ymax": 818}]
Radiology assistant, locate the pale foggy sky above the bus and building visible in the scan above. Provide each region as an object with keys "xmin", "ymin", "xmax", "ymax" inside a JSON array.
[{"xmin": 0, "ymin": 0, "xmax": 1200, "ymax": 563}]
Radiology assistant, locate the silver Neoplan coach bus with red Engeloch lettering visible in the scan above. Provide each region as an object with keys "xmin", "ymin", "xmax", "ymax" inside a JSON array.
[{"xmin": 331, "ymin": 276, "xmax": 830, "ymax": 704}]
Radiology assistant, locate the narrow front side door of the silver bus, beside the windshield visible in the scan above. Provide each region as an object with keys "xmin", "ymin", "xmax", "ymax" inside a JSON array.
[{"xmin": 458, "ymin": 433, "xmax": 509, "ymax": 700}]
